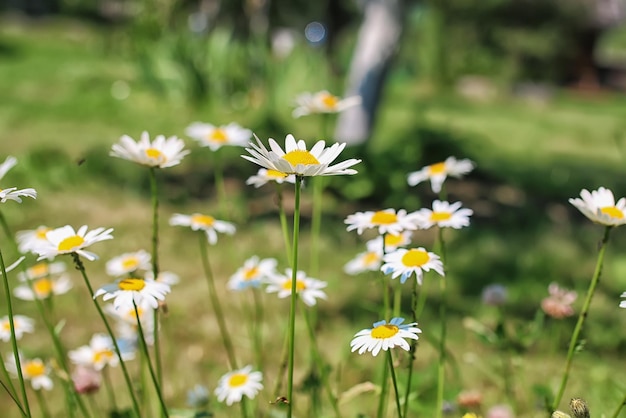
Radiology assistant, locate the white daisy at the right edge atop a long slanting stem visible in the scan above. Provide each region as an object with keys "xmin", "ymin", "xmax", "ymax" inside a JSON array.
[{"xmin": 569, "ymin": 187, "xmax": 626, "ymax": 226}]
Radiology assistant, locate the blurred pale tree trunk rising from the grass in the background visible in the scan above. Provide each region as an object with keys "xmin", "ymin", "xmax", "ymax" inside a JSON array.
[{"xmin": 335, "ymin": 0, "xmax": 402, "ymax": 145}]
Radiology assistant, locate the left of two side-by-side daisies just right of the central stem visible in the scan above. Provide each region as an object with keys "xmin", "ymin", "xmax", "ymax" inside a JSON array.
[{"xmin": 344, "ymin": 209, "xmax": 417, "ymax": 235}]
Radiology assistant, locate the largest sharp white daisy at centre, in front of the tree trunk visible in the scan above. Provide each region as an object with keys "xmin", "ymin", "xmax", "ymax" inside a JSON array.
[{"xmin": 242, "ymin": 134, "xmax": 361, "ymax": 177}]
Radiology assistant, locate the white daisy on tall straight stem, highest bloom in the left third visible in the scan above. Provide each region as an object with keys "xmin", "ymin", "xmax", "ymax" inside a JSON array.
[{"xmin": 109, "ymin": 131, "xmax": 189, "ymax": 168}]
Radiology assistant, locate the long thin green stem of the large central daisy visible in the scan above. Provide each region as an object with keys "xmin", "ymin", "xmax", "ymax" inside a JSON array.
[{"xmin": 287, "ymin": 176, "xmax": 302, "ymax": 418}]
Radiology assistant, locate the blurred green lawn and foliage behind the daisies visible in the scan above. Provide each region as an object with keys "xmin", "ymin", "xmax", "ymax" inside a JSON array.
[{"xmin": 0, "ymin": 0, "xmax": 626, "ymax": 416}]
